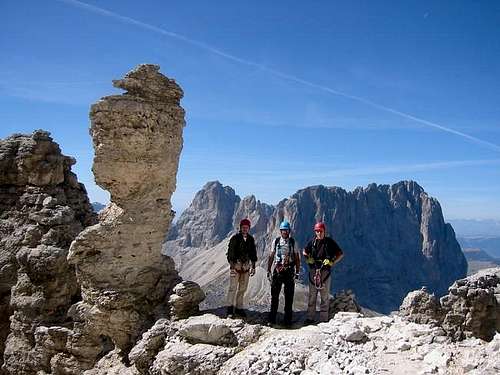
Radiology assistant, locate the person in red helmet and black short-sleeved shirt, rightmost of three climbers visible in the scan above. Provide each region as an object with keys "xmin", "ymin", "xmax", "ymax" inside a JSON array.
[{"xmin": 303, "ymin": 222, "xmax": 344, "ymax": 324}]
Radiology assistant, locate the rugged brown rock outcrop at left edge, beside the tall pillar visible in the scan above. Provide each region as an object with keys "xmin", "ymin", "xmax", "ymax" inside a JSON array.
[{"xmin": 0, "ymin": 130, "xmax": 95, "ymax": 374}]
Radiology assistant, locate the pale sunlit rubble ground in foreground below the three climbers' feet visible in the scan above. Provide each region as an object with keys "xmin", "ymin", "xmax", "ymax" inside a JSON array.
[{"xmin": 108, "ymin": 313, "xmax": 500, "ymax": 375}]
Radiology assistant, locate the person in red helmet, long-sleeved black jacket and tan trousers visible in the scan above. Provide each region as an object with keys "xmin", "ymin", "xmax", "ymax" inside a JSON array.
[{"xmin": 227, "ymin": 219, "xmax": 257, "ymax": 317}]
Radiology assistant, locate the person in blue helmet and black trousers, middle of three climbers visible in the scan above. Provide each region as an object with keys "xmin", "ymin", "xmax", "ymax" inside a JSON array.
[{"xmin": 267, "ymin": 220, "xmax": 300, "ymax": 326}]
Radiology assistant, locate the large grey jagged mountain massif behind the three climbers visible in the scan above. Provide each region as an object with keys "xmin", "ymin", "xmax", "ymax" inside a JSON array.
[{"xmin": 164, "ymin": 181, "xmax": 467, "ymax": 313}]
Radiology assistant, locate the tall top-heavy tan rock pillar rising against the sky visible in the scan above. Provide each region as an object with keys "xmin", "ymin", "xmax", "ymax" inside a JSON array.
[{"xmin": 21, "ymin": 65, "xmax": 188, "ymax": 374}]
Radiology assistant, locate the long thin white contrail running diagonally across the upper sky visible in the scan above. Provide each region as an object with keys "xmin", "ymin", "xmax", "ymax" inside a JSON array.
[{"xmin": 57, "ymin": 0, "xmax": 500, "ymax": 151}]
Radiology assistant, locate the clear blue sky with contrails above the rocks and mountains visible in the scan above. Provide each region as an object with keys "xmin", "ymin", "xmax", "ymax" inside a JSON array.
[{"xmin": 0, "ymin": 0, "xmax": 500, "ymax": 219}]
